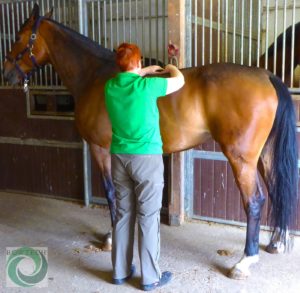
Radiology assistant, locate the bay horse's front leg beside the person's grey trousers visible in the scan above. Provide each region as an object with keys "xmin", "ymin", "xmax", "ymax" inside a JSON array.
[{"xmin": 90, "ymin": 144, "xmax": 116, "ymax": 250}]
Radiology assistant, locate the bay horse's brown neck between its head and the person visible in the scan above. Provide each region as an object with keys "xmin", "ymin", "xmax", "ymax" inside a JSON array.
[{"xmin": 41, "ymin": 22, "xmax": 116, "ymax": 98}]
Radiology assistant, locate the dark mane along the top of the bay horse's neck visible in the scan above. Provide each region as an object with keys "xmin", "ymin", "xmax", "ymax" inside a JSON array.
[{"xmin": 47, "ymin": 19, "xmax": 115, "ymax": 61}]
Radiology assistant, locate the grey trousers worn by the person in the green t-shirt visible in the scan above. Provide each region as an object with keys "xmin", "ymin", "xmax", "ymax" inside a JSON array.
[{"xmin": 112, "ymin": 154, "xmax": 164, "ymax": 285}]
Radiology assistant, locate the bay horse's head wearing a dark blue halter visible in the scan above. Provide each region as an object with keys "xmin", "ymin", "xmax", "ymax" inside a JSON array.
[{"xmin": 4, "ymin": 4, "xmax": 52, "ymax": 85}]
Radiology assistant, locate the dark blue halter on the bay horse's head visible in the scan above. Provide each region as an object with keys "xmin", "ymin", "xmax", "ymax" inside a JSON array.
[{"xmin": 5, "ymin": 17, "xmax": 44, "ymax": 92}]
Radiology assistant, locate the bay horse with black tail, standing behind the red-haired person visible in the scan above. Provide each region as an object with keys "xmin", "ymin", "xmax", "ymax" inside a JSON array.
[{"xmin": 4, "ymin": 4, "xmax": 298, "ymax": 279}]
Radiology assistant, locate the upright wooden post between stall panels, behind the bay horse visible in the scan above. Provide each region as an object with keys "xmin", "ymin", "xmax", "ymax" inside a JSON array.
[{"xmin": 168, "ymin": 0, "xmax": 185, "ymax": 226}]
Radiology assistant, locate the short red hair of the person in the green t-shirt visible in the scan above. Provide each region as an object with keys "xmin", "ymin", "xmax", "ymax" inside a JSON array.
[{"xmin": 117, "ymin": 43, "xmax": 142, "ymax": 71}]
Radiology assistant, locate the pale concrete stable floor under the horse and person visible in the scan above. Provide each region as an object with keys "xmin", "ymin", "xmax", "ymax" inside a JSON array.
[{"xmin": 0, "ymin": 192, "xmax": 300, "ymax": 293}]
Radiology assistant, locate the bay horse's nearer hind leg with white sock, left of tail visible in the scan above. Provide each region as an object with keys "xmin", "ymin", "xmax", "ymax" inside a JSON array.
[{"xmin": 224, "ymin": 150, "xmax": 265, "ymax": 279}]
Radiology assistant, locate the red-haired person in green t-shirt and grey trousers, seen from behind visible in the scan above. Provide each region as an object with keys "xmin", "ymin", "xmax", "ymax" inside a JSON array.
[{"xmin": 105, "ymin": 43, "xmax": 184, "ymax": 291}]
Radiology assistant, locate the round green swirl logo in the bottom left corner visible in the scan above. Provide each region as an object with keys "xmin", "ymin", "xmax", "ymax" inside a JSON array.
[{"xmin": 6, "ymin": 247, "xmax": 48, "ymax": 287}]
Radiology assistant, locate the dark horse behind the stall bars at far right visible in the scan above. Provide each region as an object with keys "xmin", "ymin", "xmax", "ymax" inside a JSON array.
[{"xmin": 259, "ymin": 22, "xmax": 300, "ymax": 86}]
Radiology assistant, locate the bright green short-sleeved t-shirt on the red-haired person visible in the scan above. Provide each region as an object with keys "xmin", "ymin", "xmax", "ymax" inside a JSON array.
[{"xmin": 105, "ymin": 72, "xmax": 167, "ymax": 155}]
